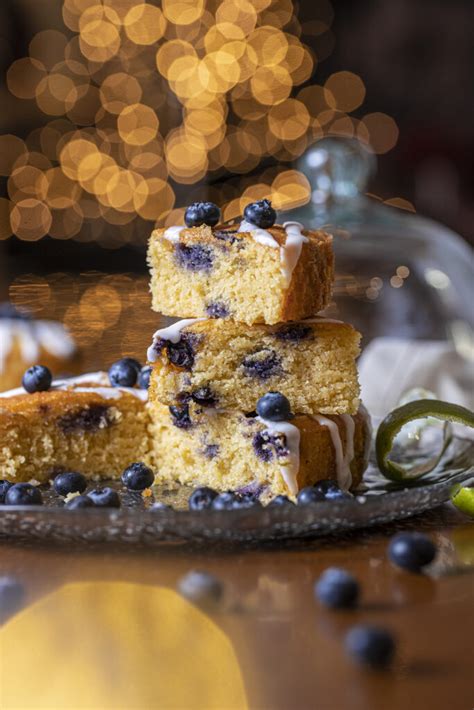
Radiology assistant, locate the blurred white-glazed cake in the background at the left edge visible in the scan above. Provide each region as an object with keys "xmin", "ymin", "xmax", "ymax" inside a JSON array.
[{"xmin": 0, "ymin": 303, "xmax": 80, "ymax": 391}]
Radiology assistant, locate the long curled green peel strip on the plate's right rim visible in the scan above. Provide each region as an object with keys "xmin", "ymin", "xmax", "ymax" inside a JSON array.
[{"xmin": 375, "ymin": 399, "xmax": 474, "ymax": 482}]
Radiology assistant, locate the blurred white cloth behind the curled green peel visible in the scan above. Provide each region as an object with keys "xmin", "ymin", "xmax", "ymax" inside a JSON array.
[{"xmin": 359, "ymin": 338, "xmax": 474, "ymax": 417}]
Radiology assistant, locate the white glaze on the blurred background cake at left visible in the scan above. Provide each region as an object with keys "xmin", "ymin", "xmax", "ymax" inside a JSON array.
[{"xmin": 0, "ymin": 318, "xmax": 76, "ymax": 372}]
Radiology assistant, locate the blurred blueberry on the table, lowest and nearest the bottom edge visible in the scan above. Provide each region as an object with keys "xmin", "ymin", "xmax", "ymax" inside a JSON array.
[{"xmin": 345, "ymin": 625, "xmax": 395, "ymax": 668}]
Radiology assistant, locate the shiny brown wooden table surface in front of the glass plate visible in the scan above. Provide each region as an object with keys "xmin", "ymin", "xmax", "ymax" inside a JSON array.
[{"xmin": 0, "ymin": 505, "xmax": 474, "ymax": 710}]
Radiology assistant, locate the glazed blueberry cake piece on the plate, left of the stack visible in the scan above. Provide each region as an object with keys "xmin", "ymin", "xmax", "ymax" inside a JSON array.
[{"xmin": 0, "ymin": 372, "xmax": 152, "ymax": 483}]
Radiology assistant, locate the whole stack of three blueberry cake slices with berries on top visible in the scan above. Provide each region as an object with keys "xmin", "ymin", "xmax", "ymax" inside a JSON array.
[{"xmin": 148, "ymin": 200, "xmax": 369, "ymax": 496}]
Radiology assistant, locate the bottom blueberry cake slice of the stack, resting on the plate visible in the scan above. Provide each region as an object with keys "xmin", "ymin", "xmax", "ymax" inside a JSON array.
[{"xmin": 149, "ymin": 401, "xmax": 370, "ymax": 500}]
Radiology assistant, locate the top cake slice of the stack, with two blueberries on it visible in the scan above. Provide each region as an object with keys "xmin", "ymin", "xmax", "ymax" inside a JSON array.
[{"xmin": 148, "ymin": 200, "xmax": 334, "ymax": 325}]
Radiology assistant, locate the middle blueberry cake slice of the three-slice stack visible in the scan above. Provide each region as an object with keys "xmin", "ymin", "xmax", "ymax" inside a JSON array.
[{"xmin": 148, "ymin": 318, "xmax": 360, "ymax": 414}]
